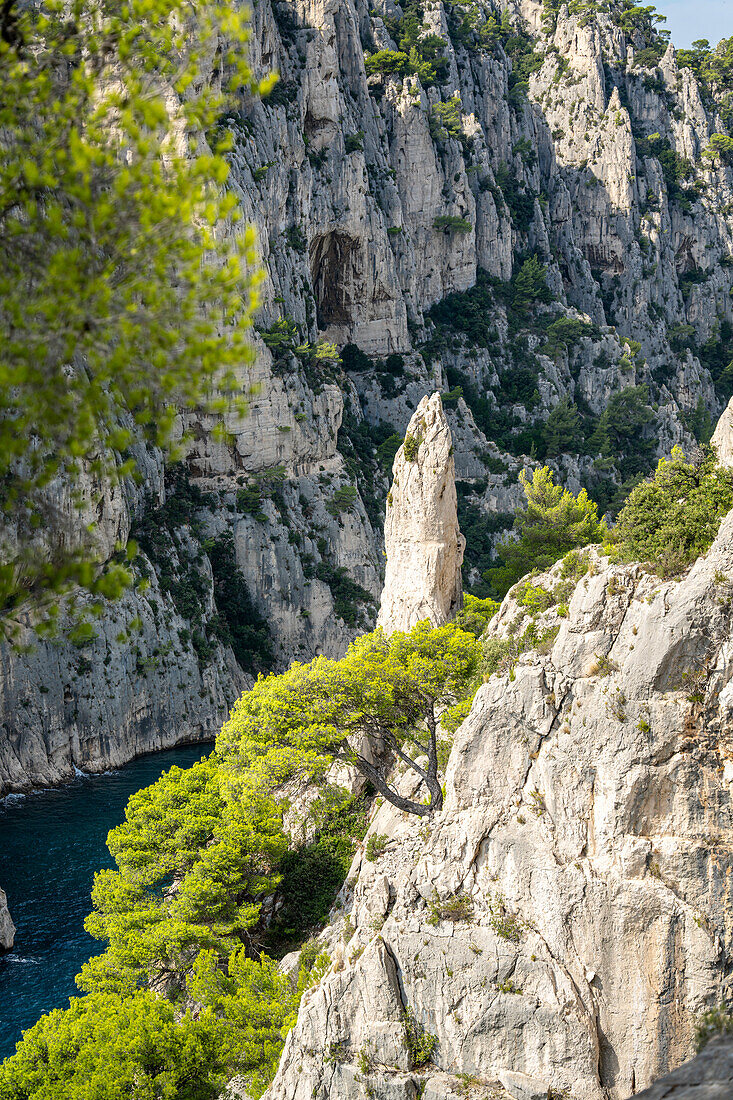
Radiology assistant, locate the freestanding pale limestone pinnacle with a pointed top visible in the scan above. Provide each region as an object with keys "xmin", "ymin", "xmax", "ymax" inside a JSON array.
[{"xmin": 376, "ymin": 394, "xmax": 466, "ymax": 634}]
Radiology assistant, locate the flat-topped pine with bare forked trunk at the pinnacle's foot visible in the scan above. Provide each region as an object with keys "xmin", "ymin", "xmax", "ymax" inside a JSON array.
[{"xmin": 217, "ymin": 622, "xmax": 480, "ymax": 815}]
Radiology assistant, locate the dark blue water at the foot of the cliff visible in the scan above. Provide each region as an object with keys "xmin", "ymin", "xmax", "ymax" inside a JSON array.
[{"xmin": 0, "ymin": 745, "xmax": 211, "ymax": 1059}]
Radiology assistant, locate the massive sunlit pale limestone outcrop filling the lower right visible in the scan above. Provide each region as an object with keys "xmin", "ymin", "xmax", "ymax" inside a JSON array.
[{"xmin": 270, "ymin": 514, "xmax": 733, "ymax": 1100}]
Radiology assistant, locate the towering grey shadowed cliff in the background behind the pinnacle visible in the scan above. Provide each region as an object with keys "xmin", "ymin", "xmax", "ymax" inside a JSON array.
[{"xmin": 0, "ymin": 0, "xmax": 733, "ymax": 791}]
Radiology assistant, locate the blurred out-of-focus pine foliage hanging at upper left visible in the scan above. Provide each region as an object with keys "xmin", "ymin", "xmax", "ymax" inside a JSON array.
[{"xmin": 0, "ymin": 0, "xmax": 268, "ymax": 631}]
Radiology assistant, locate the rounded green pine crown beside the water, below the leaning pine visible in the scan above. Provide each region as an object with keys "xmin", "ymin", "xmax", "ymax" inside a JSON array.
[{"xmin": 77, "ymin": 758, "xmax": 287, "ymax": 993}]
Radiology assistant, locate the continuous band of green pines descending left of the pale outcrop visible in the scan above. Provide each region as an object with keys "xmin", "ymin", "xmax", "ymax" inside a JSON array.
[{"xmin": 0, "ymin": 623, "xmax": 481, "ymax": 1100}]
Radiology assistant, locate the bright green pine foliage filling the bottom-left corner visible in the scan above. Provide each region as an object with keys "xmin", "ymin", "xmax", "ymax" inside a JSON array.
[{"xmin": 0, "ymin": 946, "xmax": 328, "ymax": 1100}]
